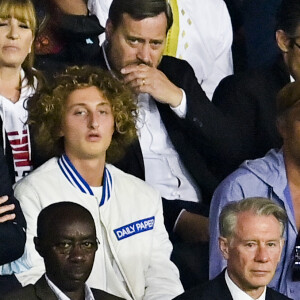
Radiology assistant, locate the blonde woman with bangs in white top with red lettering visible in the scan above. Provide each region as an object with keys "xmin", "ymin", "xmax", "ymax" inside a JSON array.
[{"xmin": 0, "ymin": 0, "xmax": 38, "ymax": 182}]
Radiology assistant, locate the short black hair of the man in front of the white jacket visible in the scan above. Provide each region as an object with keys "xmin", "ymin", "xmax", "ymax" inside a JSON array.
[{"xmin": 37, "ymin": 201, "xmax": 96, "ymax": 241}]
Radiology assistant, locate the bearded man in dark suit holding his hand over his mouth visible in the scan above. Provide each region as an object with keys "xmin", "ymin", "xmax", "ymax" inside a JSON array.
[{"xmin": 99, "ymin": 0, "xmax": 246, "ymax": 287}]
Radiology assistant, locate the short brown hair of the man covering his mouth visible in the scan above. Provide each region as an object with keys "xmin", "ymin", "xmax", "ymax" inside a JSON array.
[{"xmin": 108, "ymin": 0, "xmax": 173, "ymax": 32}]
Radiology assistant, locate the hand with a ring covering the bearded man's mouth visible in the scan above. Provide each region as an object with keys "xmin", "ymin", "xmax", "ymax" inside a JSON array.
[{"xmin": 121, "ymin": 64, "xmax": 183, "ymax": 107}]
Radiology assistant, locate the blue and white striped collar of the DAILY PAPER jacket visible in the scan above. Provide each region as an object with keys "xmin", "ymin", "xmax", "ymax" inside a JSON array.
[{"xmin": 58, "ymin": 154, "xmax": 112, "ymax": 206}]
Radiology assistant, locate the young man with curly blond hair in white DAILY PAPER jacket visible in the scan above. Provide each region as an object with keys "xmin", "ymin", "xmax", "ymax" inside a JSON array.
[{"xmin": 5, "ymin": 67, "xmax": 182, "ymax": 299}]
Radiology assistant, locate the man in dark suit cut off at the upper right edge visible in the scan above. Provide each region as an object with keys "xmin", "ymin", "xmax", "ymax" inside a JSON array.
[{"xmin": 212, "ymin": 0, "xmax": 300, "ymax": 163}]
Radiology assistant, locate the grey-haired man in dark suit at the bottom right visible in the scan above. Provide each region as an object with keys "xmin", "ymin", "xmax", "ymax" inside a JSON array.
[{"xmin": 175, "ymin": 197, "xmax": 290, "ymax": 300}]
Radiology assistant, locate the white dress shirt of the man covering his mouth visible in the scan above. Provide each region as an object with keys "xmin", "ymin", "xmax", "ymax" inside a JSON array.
[{"xmin": 137, "ymin": 93, "xmax": 201, "ymax": 202}]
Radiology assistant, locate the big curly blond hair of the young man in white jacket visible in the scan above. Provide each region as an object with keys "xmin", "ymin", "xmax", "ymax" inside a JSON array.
[{"xmin": 27, "ymin": 66, "xmax": 137, "ymax": 163}]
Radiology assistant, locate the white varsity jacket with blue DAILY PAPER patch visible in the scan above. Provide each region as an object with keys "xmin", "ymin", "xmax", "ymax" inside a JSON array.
[{"xmin": 2, "ymin": 156, "xmax": 183, "ymax": 300}]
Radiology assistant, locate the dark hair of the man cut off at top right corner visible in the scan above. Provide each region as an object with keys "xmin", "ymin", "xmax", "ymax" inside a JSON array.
[{"xmin": 276, "ymin": 0, "xmax": 300, "ymax": 38}]
